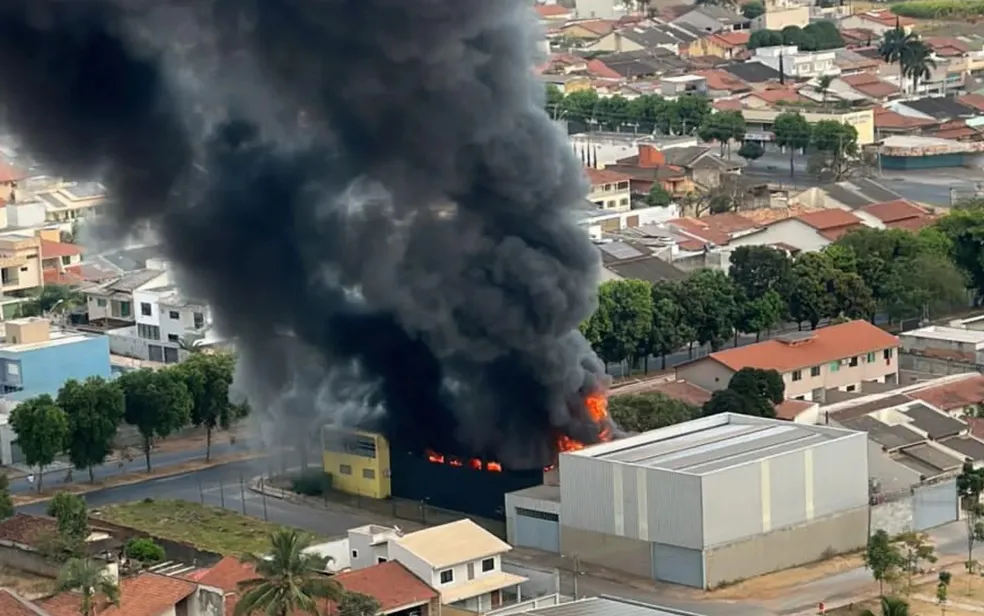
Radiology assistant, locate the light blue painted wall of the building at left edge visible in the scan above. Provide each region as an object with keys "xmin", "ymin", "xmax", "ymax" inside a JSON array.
[{"xmin": 0, "ymin": 336, "xmax": 112, "ymax": 400}]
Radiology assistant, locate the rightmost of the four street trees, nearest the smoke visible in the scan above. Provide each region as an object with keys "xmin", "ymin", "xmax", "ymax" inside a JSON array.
[{"xmin": 173, "ymin": 353, "xmax": 240, "ymax": 460}]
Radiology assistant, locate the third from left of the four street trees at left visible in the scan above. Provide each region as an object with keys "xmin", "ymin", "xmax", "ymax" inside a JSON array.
[{"xmin": 118, "ymin": 369, "xmax": 193, "ymax": 473}]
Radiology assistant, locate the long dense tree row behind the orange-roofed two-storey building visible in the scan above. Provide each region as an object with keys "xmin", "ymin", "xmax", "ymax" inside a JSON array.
[{"xmin": 581, "ymin": 225, "xmax": 964, "ymax": 369}]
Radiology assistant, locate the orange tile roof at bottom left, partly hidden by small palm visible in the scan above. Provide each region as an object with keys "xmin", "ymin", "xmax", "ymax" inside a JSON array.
[{"xmin": 39, "ymin": 573, "xmax": 198, "ymax": 616}]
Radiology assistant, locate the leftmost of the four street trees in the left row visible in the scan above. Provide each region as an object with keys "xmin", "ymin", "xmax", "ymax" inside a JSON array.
[{"xmin": 10, "ymin": 394, "xmax": 68, "ymax": 492}]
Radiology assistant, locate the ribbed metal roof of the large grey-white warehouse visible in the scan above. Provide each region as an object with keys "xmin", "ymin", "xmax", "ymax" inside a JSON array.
[{"xmin": 582, "ymin": 414, "xmax": 838, "ymax": 475}]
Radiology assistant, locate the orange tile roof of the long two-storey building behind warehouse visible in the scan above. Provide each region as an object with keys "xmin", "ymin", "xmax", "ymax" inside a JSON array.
[{"xmin": 697, "ymin": 321, "xmax": 899, "ymax": 372}]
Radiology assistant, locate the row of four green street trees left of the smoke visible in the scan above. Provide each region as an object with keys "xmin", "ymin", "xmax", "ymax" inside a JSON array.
[{"xmin": 10, "ymin": 353, "xmax": 249, "ymax": 492}]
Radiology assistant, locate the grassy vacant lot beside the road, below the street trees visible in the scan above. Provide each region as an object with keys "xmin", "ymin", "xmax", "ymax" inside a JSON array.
[{"xmin": 92, "ymin": 499, "xmax": 310, "ymax": 556}]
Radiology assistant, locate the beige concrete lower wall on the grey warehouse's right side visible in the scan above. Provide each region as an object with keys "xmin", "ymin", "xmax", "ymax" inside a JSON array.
[{"xmin": 704, "ymin": 507, "xmax": 868, "ymax": 588}]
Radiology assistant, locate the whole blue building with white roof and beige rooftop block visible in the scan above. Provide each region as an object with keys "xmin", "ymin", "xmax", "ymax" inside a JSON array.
[{"xmin": 0, "ymin": 317, "xmax": 111, "ymax": 401}]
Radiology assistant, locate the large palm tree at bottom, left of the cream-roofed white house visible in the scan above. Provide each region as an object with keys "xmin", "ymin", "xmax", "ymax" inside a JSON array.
[{"xmin": 234, "ymin": 529, "xmax": 343, "ymax": 616}]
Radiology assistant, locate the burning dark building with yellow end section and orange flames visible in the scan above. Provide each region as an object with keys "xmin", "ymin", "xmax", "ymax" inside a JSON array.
[{"xmin": 322, "ymin": 393, "xmax": 613, "ymax": 520}]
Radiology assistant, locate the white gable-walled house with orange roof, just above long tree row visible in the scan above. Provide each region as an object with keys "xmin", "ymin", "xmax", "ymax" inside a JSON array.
[{"xmin": 728, "ymin": 209, "xmax": 864, "ymax": 253}]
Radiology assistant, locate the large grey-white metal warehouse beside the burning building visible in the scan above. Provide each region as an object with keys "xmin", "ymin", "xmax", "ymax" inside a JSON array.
[{"xmin": 542, "ymin": 414, "xmax": 868, "ymax": 588}]
